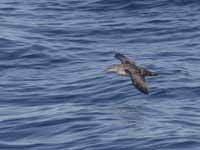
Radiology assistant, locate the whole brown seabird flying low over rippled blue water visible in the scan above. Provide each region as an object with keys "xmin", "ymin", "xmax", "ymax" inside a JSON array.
[{"xmin": 107, "ymin": 53, "xmax": 158, "ymax": 94}]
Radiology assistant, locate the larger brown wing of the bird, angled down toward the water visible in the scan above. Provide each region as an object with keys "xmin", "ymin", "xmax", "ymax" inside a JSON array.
[{"xmin": 125, "ymin": 68, "xmax": 149, "ymax": 94}]
